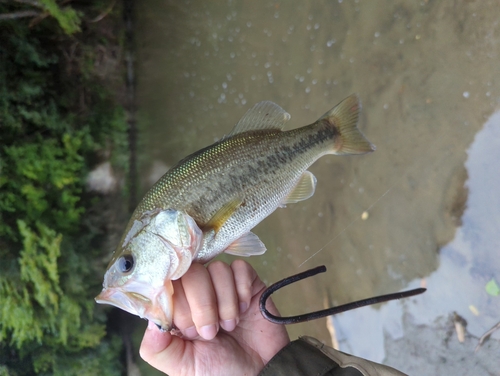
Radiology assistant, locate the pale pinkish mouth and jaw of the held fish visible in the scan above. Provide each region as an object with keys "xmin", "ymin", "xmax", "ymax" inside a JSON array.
[{"xmin": 95, "ymin": 281, "xmax": 173, "ymax": 331}]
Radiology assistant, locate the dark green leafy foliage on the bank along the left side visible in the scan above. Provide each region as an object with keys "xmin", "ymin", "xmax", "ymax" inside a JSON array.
[{"xmin": 0, "ymin": 0, "xmax": 127, "ymax": 375}]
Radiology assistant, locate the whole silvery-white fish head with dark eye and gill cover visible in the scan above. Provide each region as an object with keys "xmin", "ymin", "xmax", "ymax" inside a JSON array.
[{"xmin": 96, "ymin": 209, "xmax": 203, "ymax": 330}]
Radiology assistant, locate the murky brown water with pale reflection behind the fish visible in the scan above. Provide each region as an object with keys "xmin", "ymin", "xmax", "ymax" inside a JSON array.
[{"xmin": 137, "ymin": 0, "xmax": 500, "ymax": 374}]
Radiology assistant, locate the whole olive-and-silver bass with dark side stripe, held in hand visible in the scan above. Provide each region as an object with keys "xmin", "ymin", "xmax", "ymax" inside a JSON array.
[{"xmin": 95, "ymin": 94, "xmax": 375, "ymax": 331}]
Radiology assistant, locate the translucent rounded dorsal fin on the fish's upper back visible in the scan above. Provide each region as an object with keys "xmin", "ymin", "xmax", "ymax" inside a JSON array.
[{"xmin": 229, "ymin": 101, "xmax": 291, "ymax": 136}]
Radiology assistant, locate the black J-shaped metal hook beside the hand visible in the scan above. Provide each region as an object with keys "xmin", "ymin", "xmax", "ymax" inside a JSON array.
[{"xmin": 259, "ymin": 265, "xmax": 427, "ymax": 325}]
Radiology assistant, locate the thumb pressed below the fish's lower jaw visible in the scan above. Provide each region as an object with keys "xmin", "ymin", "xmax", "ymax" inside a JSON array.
[{"xmin": 139, "ymin": 321, "xmax": 184, "ymax": 373}]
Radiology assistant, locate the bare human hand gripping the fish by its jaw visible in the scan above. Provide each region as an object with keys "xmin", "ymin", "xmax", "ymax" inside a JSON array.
[{"xmin": 140, "ymin": 260, "xmax": 290, "ymax": 376}]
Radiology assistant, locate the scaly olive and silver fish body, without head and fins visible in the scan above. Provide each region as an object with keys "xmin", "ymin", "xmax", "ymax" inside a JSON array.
[{"xmin": 133, "ymin": 123, "xmax": 332, "ymax": 261}]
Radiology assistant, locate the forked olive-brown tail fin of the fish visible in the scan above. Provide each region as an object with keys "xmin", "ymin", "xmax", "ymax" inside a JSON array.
[{"xmin": 318, "ymin": 94, "xmax": 375, "ymax": 155}]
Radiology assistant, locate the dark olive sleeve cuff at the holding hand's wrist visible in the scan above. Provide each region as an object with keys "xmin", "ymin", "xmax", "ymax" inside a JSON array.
[{"xmin": 259, "ymin": 337, "xmax": 405, "ymax": 376}]
